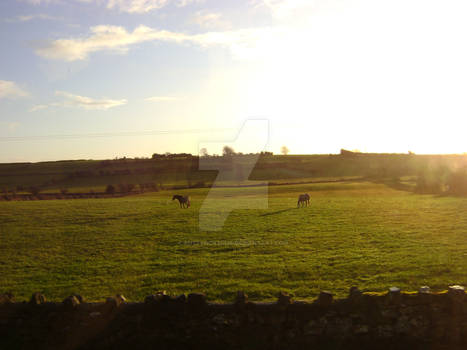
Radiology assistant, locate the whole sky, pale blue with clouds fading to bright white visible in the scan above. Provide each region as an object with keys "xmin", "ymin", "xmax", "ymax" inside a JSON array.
[{"xmin": 0, "ymin": 0, "xmax": 467, "ymax": 162}]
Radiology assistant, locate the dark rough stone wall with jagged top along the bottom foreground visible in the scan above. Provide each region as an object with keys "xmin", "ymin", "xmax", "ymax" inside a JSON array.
[{"xmin": 0, "ymin": 286, "xmax": 467, "ymax": 350}]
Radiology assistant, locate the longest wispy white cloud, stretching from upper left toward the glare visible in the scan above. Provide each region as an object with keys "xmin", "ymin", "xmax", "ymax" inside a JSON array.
[{"xmin": 35, "ymin": 25, "xmax": 278, "ymax": 61}]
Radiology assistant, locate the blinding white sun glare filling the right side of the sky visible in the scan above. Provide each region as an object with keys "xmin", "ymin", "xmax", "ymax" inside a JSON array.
[{"xmin": 232, "ymin": 2, "xmax": 467, "ymax": 153}]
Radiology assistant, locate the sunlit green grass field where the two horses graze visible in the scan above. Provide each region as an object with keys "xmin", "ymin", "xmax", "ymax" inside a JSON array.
[{"xmin": 0, "ymin": 182, "xmax": 467, "ymax": 301}]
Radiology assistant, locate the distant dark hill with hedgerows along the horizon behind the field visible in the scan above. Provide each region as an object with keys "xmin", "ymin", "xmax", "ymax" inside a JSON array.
[{"xmin": 0, "ymin": 150, "xmax": 467, "ymax": 192}]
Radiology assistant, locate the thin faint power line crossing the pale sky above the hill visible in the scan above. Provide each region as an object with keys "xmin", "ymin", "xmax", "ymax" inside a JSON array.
[{"xmin": 0, "ymin": 128, "xmax": 238, "ymax": 142}]
